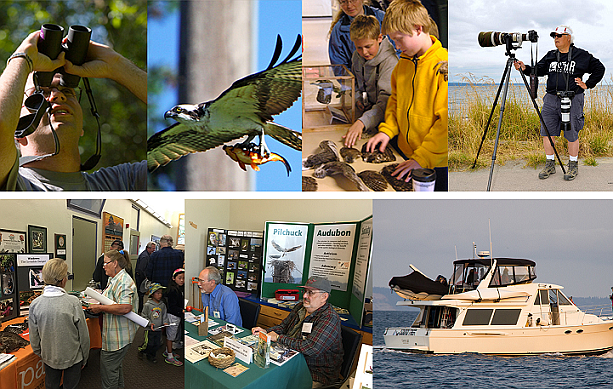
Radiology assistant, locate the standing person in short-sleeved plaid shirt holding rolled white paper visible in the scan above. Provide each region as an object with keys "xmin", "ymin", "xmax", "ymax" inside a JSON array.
[{"xmin": 91, "ymin": 250, "xmax": 137, "ymax": 389}]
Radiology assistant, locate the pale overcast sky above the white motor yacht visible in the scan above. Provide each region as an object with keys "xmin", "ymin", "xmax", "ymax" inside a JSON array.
[{"xmin": 372, "ymin": 199, "xmax": 613, "ymax": 297}]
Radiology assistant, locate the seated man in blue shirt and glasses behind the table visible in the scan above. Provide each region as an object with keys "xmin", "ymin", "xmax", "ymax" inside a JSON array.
[{"xmin": 198, "ymin": 266, "xmax": 243, "ymax": 327}]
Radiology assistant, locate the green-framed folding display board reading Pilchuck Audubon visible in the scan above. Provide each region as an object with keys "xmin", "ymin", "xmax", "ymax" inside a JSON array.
[{"xmin": 262, "ymin": 216, "xmax": 372, "ymax": 325}]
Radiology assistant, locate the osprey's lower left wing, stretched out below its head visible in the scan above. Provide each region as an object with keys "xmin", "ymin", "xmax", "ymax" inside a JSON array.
[{"xmin": 147, "ymin": 123, "xmax": 245, "ymax": 172}]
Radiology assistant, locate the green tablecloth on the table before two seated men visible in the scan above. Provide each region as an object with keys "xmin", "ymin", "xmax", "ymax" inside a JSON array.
[{"xmin": 184, "ymin": 312, "xmax": 312, "ymax": 389}]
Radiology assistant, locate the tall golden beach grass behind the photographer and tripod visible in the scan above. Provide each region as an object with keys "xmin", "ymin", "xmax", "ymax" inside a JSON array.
[{"xmin": 448, "ymin": 76, "xmax": 613, "ymax": 171}]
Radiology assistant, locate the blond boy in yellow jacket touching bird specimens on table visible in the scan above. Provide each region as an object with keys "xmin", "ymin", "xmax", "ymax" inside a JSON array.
[{"xmin": 367, "ymin": 0, "xmax": 448, "ymax": 191}]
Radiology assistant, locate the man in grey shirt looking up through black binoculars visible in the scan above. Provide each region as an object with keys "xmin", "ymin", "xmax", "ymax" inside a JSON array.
[{"xmin": 0, "ymin": 25, "xmax": 147, "ymax": 191}]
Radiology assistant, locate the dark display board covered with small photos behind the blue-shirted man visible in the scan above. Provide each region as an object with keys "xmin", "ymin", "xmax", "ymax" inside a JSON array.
[{"xmin": 206, "ymin": 228, "xmax": 264, "ymax": 297}]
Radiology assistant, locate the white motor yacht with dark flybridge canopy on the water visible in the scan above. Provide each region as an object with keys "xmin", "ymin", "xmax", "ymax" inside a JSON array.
[{"xmin": 384, "ymin": 252, "xmax": 613, "ymax": 355}]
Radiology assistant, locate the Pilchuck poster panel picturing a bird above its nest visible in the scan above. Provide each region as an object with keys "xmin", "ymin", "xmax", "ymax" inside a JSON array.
[{"xmin": 264, "ymin": 222, "xmax": 309, "ymax": 284}]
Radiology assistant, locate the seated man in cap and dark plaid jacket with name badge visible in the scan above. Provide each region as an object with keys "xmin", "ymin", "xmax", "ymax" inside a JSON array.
[{"xmin": 251, "ymin": 277, "xmax": 343, "ymax": 388}]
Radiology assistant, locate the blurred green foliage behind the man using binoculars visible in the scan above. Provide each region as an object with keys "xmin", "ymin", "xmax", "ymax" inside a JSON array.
[{"xmin": 0, "ymin": 0, "xmax": 147, "ymax": 169}]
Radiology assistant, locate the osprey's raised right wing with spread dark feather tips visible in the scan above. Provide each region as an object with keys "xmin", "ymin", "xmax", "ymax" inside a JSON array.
[{"xmin": 210, "ymin": 35, "xmax": 302, "ymax": 123}]
